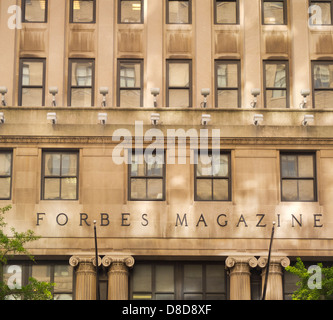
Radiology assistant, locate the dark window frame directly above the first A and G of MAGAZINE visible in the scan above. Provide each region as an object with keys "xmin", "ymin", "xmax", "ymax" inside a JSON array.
[{"xmin": 194, "ymin": 150, "xmax": 232, "ymax": 202}]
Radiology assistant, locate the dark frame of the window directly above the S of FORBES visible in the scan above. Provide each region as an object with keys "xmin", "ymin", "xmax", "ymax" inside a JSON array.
[{"xmin": 127, "ymin": 149, "xmax": 166, "ymax": 202}]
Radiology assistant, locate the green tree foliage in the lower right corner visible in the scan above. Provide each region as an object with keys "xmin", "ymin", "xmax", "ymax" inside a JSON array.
[{"xmin": 286, "ymin": 258, "xmax": 333, "ymax": 300}]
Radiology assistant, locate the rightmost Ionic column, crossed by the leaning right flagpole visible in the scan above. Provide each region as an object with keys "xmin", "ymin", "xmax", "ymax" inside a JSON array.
[{"xmin": 258, "ymin": 257, "xmax": 290, "ymax": 300}]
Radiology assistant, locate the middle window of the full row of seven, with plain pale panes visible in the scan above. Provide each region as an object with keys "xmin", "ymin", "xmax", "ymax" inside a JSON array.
[{"xmin": 166, "ymin": 60, "xmax": 192, "ymax": 108}]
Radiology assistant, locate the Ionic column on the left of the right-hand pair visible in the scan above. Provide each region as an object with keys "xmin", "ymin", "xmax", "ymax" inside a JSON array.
[{"xmin": 226, "ymin": 256, "xmax": 258, "ymax": 300}]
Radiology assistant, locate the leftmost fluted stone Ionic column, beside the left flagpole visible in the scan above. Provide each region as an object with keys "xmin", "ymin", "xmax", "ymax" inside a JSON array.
[{"xmin": 69, "ymin": 256, "xmax": 101, "ymax": 300}]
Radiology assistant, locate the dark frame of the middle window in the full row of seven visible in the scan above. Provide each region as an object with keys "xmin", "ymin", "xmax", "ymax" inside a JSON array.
[{"xmin": 166, "ymin": 59, "xmax": 193, "ymax": 109}]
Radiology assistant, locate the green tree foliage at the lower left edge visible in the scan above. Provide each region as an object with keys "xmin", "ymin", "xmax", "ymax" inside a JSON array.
[{"xmin": 0, "ymin": 206, "xmax": 54, "ymax": 300}]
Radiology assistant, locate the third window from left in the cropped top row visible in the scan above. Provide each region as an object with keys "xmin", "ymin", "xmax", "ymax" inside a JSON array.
[{"xmin": 118, "ymin": 0, "xmax": 143, "ymax": 23}]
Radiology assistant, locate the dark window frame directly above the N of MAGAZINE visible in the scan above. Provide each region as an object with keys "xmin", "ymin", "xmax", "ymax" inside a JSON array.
[{"xmin": 279, "ymin": 150, "xmax": 318, "ymax": 203}]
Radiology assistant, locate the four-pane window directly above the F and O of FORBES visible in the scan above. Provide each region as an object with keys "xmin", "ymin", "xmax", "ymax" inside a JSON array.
[{"xmin": 42, "ymin": 151, "xmax": 78, "ymax": 200}]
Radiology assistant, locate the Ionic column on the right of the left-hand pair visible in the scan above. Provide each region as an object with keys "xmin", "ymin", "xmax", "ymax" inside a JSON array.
[{"xmin": 102, "ymin": 256, "xmax": 134, "ymax": 300}]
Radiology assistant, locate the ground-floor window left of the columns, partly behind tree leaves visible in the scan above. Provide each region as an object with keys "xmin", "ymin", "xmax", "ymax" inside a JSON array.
[{"xmin": 0, "ymin": 261, "xmax": 73, "ymax": 300}]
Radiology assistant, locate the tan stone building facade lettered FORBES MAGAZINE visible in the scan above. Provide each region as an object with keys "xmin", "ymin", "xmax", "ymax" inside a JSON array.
[{"xmin": 0, "ymin": 0, "xmax": 333, "ymax": 300}]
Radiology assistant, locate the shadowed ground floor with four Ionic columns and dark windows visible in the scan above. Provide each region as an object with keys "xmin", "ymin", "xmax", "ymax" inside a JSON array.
[{"xmin": 1, "ymin": 253, "xmax": 332, "ymax": 300}]
